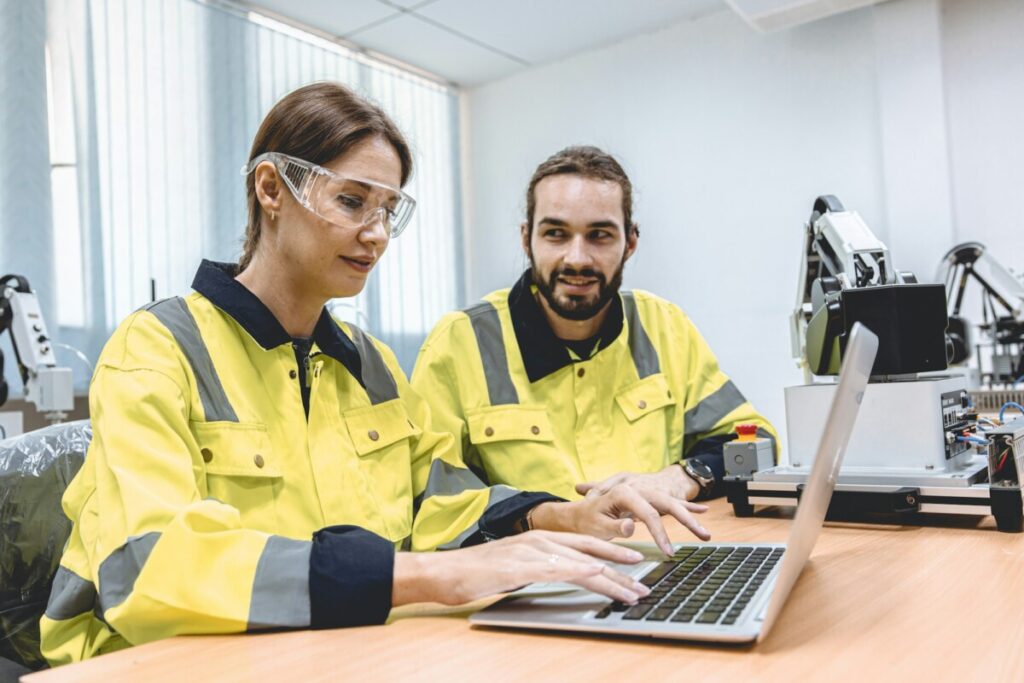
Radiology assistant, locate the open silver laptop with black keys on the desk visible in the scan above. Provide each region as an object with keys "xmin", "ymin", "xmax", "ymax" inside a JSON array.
[{"xmin": 470, "ymin": 324, "xmax": 879, "ymax": 643}]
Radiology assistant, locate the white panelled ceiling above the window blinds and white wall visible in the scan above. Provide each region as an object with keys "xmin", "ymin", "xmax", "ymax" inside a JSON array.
[{"xmin": 244, "ymin": 0, "xmax": 726, "ymax": 87}]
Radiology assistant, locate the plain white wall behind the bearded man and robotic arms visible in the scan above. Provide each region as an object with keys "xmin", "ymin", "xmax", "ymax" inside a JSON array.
[{"xmin": 464, "ymin": 0, "xmax": 1024, "ymax": 450}]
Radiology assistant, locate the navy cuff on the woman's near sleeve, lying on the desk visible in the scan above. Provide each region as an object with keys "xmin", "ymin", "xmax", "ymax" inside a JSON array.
[{"xmin": 309, "ymin": 524, "xmax": 394, "ymax": 629}]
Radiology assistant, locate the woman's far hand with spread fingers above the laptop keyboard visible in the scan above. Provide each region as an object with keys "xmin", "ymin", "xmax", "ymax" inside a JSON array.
[{"xmin": 530, "ymin": 483, "xmax": 711, "ymax": 555}]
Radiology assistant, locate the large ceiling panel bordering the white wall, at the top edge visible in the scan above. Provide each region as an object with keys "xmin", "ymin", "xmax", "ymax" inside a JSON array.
[{"xmin": 416, "ymin": 0, "xmax": 726, "ymax": 63}]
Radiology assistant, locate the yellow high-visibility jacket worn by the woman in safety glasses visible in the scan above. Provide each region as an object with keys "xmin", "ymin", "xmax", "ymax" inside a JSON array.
[{"xmin": 41, "ymin": 262, "xmax": 454, "ymax": 664}]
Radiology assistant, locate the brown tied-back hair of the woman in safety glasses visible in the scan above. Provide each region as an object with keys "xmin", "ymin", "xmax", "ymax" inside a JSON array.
[{"xmin": 239, "ymin": 83, "xmax": 413, "ymax": 272}]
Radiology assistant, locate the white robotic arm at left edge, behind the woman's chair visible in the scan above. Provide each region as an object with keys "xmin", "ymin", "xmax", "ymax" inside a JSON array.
[{"xmin": 0, "ymin": 275, "xmax": 75, "ymax": 420}]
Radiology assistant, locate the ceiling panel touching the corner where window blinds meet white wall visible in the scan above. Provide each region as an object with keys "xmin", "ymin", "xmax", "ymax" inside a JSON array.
[{"xmin": 351, "ymin": 14, "xmax": 522, "ymax": 85}]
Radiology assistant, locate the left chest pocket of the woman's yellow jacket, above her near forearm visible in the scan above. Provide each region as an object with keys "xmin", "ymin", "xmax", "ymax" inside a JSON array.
[{"xmin": 191, "ymin": 422, "xmax": 284, "ymax": 529}]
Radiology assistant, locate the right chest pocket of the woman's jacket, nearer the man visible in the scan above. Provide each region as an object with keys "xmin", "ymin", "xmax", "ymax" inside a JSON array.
[{"xmin": 342, "ymin": 398, "xmax": 416, "ymax": 542}]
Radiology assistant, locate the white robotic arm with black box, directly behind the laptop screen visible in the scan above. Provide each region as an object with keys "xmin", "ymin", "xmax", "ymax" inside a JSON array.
[{"xmin": 791, "ymin": 195, "xmax": 947, "ymax": 376}]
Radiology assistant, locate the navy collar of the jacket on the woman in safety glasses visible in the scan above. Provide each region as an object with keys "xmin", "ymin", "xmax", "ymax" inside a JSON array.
[{"xmin": 193, "ymin": 259, "xmax": 362, "ymax": 384}]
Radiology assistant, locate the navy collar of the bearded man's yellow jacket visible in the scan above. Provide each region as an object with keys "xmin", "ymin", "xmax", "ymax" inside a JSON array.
[{"xmin": 508, "ymin": 269, "xmax": 623, "ymax": 382}]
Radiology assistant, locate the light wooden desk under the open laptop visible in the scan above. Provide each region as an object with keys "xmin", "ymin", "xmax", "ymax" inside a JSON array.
[{"xmin": 24, "ymin": 501, "xmax": 1024, "ymax": 683}]
